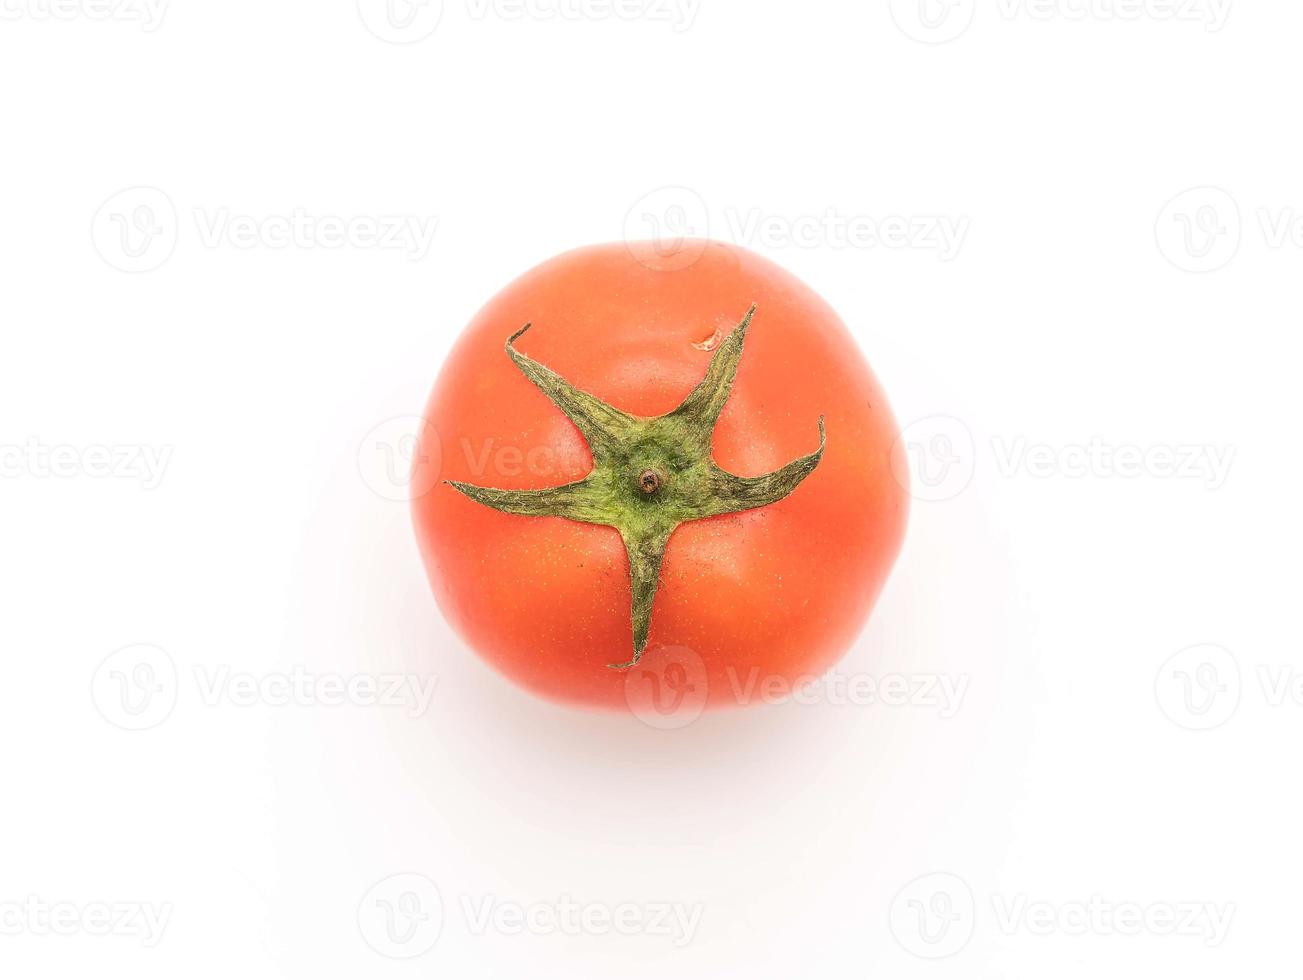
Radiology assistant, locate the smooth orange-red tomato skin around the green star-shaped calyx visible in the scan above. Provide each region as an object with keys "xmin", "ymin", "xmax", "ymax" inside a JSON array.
[{"xmin": 412, "ymin": 241, "xmax": 908, "ymax": 709}]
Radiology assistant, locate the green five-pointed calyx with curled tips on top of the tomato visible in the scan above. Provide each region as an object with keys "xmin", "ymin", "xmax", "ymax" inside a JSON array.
[{"xmin": 448, "ymin": 306, "xmax": 826, "ymax": 670}]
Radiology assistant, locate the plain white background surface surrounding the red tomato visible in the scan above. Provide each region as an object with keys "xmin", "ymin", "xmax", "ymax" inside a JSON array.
[{"xmin": 0, "ymin": 0, "xmax": 1303, "ymax": 979}]
